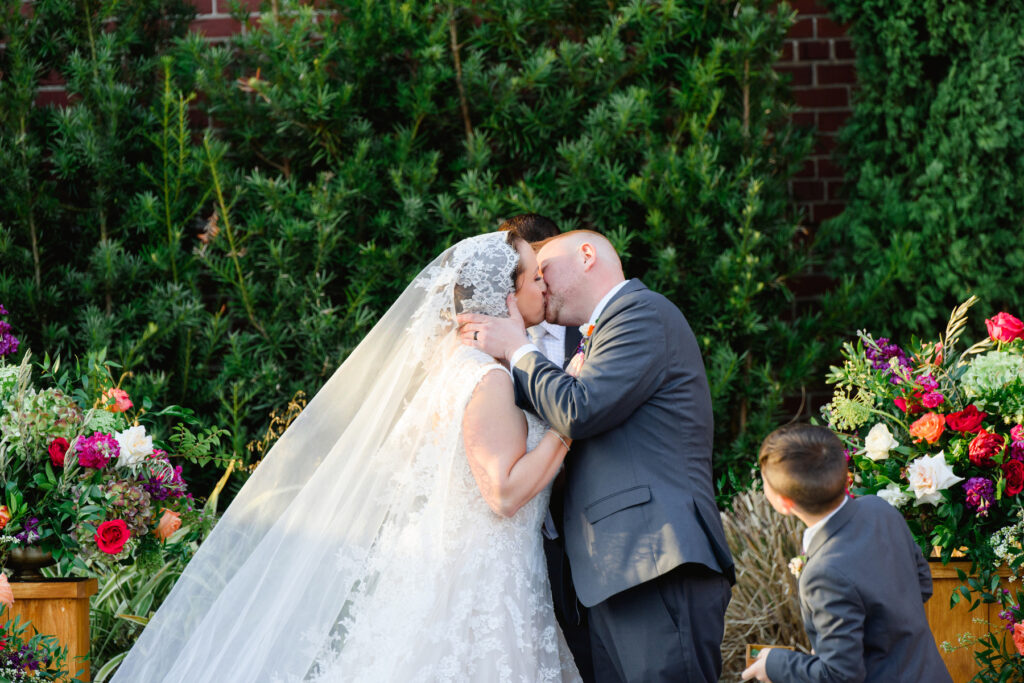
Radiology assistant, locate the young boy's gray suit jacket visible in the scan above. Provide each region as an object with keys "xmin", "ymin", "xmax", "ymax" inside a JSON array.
[{"xmin": 765, "ymin": 496, "xmax": 952, "ymax": 683}]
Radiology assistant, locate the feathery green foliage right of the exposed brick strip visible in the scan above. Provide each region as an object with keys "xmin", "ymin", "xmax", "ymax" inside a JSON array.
[{"xmin": 827, "ymin": 0, "xmax": 1024, "ymax": 339}]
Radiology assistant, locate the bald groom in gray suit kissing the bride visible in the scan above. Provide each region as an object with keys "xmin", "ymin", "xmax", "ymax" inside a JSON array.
[{"xmin": 459, "ymin": 230, "xmax": 735, "ymax": 683}]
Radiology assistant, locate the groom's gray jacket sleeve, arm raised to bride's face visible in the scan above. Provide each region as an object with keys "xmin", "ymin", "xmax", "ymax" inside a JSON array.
[{"xmin": 514, "ymin": 299, "xmax": 666, "ymax": 438}]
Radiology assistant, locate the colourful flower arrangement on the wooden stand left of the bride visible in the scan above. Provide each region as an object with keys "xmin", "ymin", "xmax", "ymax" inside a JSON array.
[{"xmin": 0, "ymin": 317, "xmax": 222, "ymax": 575}]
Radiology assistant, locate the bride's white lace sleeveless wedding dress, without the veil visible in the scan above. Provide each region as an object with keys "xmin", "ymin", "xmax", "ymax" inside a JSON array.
[{"xmin": 296, "ymin": 347, "xmax": 578, "ymax": 683}]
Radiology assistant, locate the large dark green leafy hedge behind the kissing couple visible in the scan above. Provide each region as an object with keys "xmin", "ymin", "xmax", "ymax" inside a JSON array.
[{"xmin": 0, "ymin": 0, "xmax": 828, "ymax": 502}]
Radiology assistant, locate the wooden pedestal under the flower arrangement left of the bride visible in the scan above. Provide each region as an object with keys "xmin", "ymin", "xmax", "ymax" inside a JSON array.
[{"xmin": 5, "ymin": 579, "xmax": 97, "ymax": 681}]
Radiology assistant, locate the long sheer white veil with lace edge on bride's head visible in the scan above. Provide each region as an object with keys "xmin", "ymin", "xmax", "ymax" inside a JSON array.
[{"xmin": 114, "ymin": 232, "xmax": 518, "ymax": 683}]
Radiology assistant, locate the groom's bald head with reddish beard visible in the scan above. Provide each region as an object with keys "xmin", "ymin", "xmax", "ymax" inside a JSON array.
[{"xmin": 535, "ymin": 230, "xmax": 625, "ymax": 325}]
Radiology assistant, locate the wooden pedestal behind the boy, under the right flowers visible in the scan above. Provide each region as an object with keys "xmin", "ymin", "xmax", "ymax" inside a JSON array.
[{"xmin": 925, "ymin": 561, "xmax": 1010, "ymax": 683}]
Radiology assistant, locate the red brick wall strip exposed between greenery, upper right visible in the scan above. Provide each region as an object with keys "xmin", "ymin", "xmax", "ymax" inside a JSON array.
[{"xmin": 776, "ymin": 0, "xmax": 857, "ymax": 227}]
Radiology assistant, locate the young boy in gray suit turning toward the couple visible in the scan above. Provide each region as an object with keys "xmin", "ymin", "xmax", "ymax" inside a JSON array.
[{"xmin": 743, "ymin": 424, "xmax": 952, "ymax": 683}]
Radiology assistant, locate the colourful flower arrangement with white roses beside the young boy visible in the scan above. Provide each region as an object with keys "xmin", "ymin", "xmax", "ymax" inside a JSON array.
[{"xmin": 821, "ymin": 297, "xmax": 1024, "ymax": 680}]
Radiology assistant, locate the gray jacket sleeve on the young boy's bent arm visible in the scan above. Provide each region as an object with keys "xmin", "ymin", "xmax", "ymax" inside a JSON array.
[{"xmin": 765, "ymin": 571, "xmax": 867, "ymax": 683}]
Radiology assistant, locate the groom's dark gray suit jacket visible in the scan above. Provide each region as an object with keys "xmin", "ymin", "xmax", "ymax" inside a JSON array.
[{"xmin": 513, "ymin": 280, "xmax": 735, "ymax": 607}]
